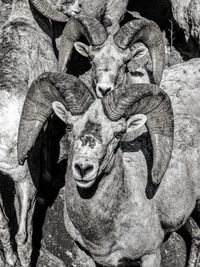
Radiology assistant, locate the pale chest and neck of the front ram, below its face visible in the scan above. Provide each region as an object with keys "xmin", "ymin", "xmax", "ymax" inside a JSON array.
[{"xmin": 64, "ymin": 148, "xmax": 164, "ymax": 266}]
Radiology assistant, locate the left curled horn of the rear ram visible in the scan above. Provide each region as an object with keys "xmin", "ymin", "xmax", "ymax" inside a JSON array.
[{"xmin": 59, "ymin": 15, "xmax": 107, "ymax": 71}]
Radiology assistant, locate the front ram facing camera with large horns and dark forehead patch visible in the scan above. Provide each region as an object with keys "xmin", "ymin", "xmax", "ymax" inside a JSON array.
[{"xmin": 18, "ymin": 73, "xmax": 177, "ymax": 267}]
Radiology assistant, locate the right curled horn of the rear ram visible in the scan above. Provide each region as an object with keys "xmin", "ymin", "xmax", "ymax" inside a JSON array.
[{"xmin": 114, "ymin": 19, "xmax": 165, "ymax": 85}]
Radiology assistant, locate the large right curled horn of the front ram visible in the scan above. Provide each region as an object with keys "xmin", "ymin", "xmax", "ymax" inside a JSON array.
[{"xmin": 103, "ymin": 84, "xmax": 174, "ymax": 184}]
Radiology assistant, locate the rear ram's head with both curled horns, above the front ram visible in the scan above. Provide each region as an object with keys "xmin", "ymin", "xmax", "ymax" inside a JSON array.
[{"xmin": 59, "ymin": 15, "xmax": 165, "ymax": 98}]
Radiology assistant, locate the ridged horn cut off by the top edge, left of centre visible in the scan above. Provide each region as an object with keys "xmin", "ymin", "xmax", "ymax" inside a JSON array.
[{"xmin": 30, "ymin": 0, "xmax": 69, "ymax": 22}]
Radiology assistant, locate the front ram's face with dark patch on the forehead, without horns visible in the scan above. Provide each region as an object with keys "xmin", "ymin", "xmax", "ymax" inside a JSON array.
[{"xmin": 53, "ymin": 99, "xmax": 144, "ymax": 188}]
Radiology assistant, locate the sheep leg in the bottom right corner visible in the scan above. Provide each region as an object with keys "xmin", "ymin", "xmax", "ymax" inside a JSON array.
[{"xmin": 184, "ymin": 217, "xmax": 200, "ymax": 267}]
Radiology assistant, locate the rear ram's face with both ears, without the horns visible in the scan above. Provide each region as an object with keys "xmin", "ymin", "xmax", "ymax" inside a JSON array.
[{"xmin": 74, "ymin": 36, "xmax": 148, "ymax": 98}]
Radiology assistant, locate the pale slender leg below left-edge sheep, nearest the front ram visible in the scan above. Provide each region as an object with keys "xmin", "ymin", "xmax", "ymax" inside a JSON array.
[{"xmin": 16, "ymin": 178, "xmax": 36, "ymax": 267}]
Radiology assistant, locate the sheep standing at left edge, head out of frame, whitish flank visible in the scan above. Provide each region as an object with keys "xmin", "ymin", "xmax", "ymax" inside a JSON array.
[{"xmin": 0, "ymin": 0, "xmax": 58, "ymax": 267}]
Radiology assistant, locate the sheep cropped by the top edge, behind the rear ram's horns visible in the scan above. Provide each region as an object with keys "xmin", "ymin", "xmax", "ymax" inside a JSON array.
[{"xmin": 30, "ymin": 0, "xmax": 128, "ymax": 26}]
